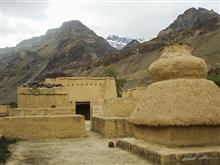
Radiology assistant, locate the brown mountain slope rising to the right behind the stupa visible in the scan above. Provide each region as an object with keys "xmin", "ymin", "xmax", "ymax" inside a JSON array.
[{"xmin": 70, "ymin": 8, "xmax": 220, "ymax": 88}]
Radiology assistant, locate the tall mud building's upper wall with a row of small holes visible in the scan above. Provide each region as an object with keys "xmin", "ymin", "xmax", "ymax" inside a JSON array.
[{"xmin": 45, "ymin": 77, "xmax": 117, "ymax": 102}]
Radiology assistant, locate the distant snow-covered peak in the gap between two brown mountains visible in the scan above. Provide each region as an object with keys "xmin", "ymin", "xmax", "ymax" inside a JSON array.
[{"xmin": 106, "ymin": 35, "xmax": 144, "ymax": 50}]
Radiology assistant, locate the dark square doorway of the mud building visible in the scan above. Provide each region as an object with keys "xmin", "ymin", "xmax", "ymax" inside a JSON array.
[{"xmin": 76, "ymin": 102, "xmax": 90, "ymax": 120}]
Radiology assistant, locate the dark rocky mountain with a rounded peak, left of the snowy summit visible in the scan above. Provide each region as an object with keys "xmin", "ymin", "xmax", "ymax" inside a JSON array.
[{"xmin": 0, "ymin": 21, "xmax": 115, "ymax": 103}]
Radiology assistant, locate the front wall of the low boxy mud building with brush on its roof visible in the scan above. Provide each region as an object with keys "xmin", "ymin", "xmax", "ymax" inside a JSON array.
[{"xmin": 17, "ymin": 87, "xmax": 70, "ymax": 108}]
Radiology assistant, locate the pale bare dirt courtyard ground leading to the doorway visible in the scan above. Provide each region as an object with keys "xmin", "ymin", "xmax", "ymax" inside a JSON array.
[{"xmin": 6, "ymin": 122, "xmax": 149, "ymax": 165}]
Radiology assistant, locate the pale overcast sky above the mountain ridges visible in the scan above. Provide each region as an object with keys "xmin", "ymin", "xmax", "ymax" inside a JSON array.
[{"xmin": 0, "ymin": 0, "xmax": 220, "ymax": 47}]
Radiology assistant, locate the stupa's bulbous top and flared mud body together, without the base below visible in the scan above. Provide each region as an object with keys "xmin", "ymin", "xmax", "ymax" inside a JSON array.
[{"xmin": 129, "ymin": 44, "xmax": 220, "ymax": 126}]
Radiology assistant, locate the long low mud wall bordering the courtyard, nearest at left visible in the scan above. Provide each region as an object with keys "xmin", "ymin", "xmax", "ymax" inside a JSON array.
[{"xmin": 0, "ymin": 115, "xmax": 85, "ymax": 139}]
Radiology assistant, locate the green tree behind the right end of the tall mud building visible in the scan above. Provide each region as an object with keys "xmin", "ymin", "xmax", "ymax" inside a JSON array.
[{"xmin": 103, "ymin": 67, "xmax": 126, "ymax": 97}]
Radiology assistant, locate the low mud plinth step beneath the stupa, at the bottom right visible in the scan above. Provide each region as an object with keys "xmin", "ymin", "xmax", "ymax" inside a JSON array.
[{"xmin": 116, "ymin": 138, "xmax": 220, "ymax": 165}]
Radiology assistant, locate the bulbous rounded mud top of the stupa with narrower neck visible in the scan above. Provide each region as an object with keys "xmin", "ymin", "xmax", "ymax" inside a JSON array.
[{"xmin": 149, "ymin": 44, "xmax": 208, "ymax": 81}]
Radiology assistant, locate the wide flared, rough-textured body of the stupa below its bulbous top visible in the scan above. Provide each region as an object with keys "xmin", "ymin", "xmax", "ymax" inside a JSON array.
[{"xmin": 130, "ymin": 78, "xmax": 220, "ymax": 126}]
